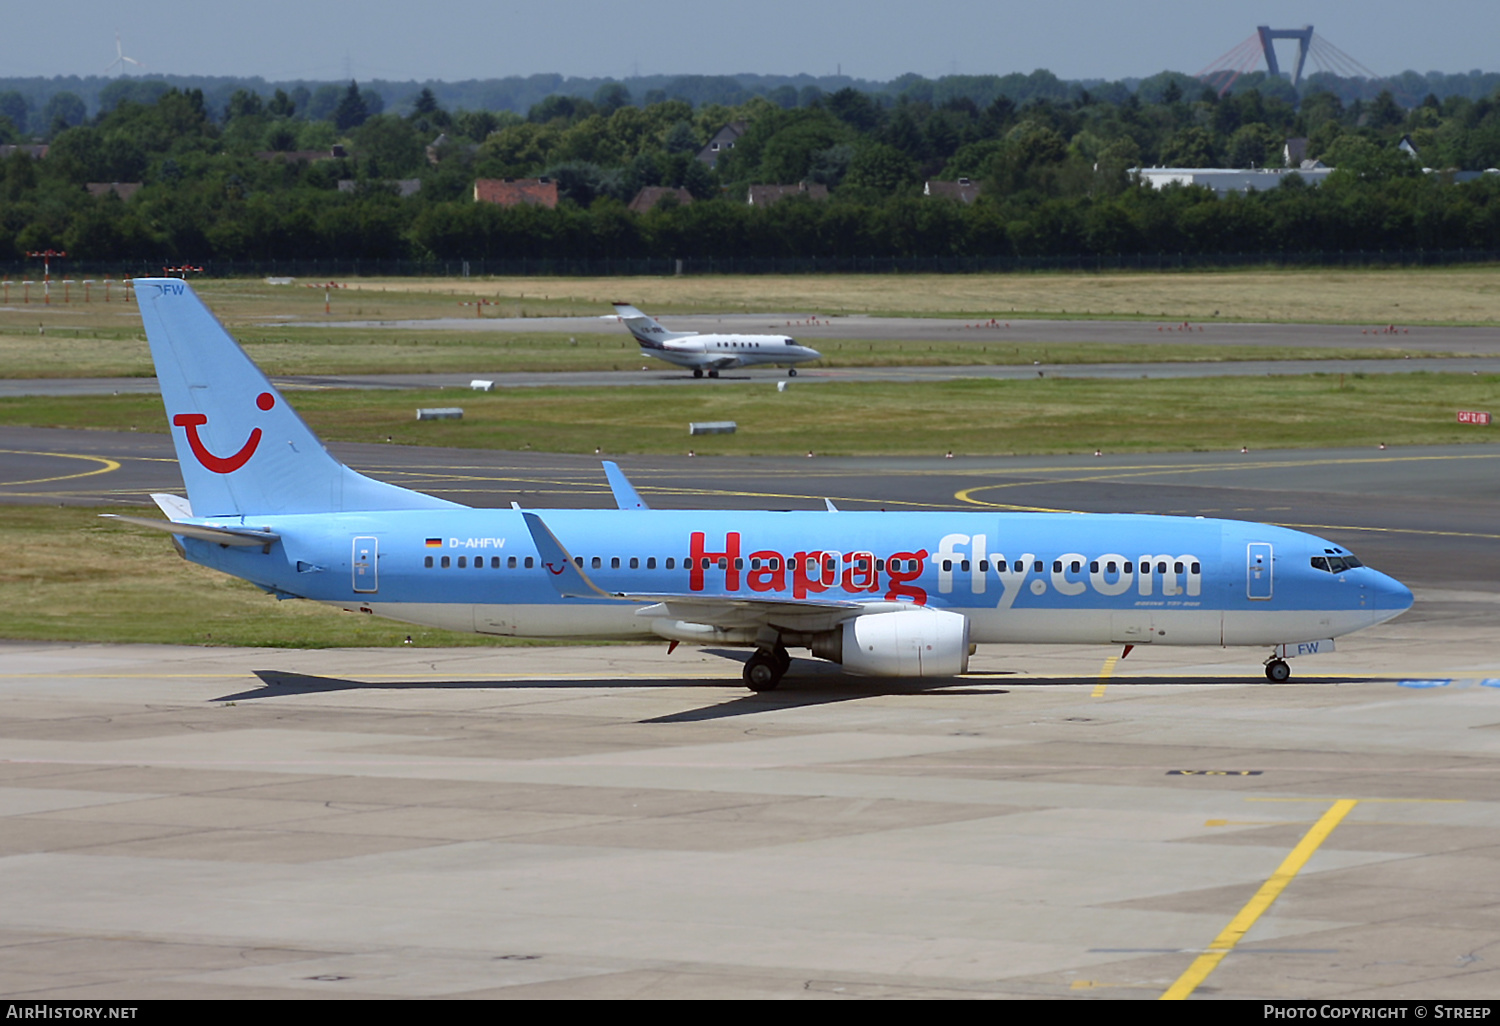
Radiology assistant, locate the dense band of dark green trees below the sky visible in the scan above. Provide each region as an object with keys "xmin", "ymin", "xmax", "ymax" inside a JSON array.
[{"xmin": 0, "ymin": 77, "xmax": 1500, "ymax": 264}]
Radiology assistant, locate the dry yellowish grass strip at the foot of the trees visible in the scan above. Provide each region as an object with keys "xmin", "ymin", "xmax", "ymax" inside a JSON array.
[{"xmin": 0, "ymin": 270, "xmax": 1500, "ymax": 333}]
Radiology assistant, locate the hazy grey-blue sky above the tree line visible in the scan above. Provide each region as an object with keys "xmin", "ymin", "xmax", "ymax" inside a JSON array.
[{"xmin": 0, "ymin": 0, "xmax": 1500, "ymax": 81}]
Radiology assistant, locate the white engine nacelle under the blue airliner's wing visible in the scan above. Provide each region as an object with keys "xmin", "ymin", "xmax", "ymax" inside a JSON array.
[{"xmin": 809, "ymin": 609, "xmax": 972, "ymax": 677}]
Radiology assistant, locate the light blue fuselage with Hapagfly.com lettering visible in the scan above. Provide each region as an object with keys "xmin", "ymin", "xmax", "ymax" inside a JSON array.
[{"xmin": 183, "ymin": 509, "xmax": 1412, "ymax": 645}]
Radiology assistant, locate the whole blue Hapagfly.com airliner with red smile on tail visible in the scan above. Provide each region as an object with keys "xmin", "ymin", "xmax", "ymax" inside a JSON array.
[{"xmin": 111, "ymin": 279, "xmax": 1412, "ymax": 690}]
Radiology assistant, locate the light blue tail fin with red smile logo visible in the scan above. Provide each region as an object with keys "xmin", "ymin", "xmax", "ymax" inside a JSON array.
[{"xmin": 135, "ymin": 278, "xmax": 458, "ymax": 518}]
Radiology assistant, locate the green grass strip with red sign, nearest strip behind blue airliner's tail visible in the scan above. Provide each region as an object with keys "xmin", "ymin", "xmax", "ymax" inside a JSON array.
[{"xmin": 0, "ymin": 374, "xmax": 1500, "ymax": 456}]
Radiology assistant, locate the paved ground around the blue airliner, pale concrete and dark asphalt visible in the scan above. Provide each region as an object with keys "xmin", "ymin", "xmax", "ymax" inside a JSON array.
[{"xmin": 0, "ymin": 429, "xmax": 1500, "ymax": 1001}]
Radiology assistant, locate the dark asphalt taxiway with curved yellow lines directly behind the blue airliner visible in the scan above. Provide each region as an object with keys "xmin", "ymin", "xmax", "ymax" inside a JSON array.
[{"xmin": 0, "ymin": 428, "xmax": 1500, "ymax": 591}]
